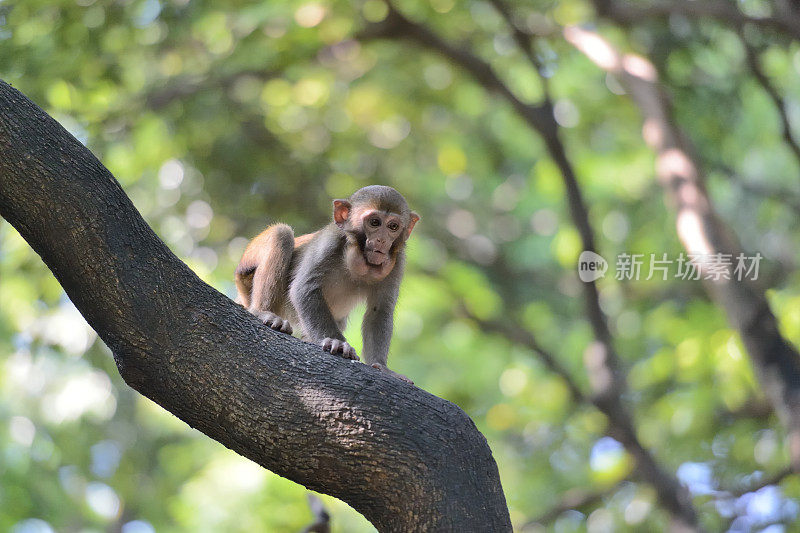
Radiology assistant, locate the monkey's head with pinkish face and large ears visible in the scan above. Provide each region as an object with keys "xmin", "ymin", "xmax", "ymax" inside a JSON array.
[{"xmin": 333, "ymin": 185, "xmax": 419, "ymax": 270}]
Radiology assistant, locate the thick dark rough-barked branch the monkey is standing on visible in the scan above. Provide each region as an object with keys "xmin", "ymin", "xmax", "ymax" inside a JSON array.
[{"xmin": 0, "ymin": 82, "xmax": 511, "ymax": 531}]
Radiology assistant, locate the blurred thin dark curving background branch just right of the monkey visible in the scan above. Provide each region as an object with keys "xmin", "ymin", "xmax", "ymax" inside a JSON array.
[{"xmin": 359, "ymin": 8, "xmax": 698, "ymax": 529}]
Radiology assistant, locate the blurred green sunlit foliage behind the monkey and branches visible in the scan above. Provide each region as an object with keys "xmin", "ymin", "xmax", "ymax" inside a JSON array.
[{"xmin": 0, "ymin": 0, "xmax": 800, "ymax": 533}]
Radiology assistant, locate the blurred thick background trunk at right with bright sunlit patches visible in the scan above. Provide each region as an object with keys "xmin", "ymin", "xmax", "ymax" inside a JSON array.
[{"xmin": 564, "ymin": 27, "xmax": 800, "ymax": 468}]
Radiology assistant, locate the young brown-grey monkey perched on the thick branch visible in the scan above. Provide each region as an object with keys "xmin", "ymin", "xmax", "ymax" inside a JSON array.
[{"xmin": 236, "ymin": 185, "xmax": 419, "ymax": 382}]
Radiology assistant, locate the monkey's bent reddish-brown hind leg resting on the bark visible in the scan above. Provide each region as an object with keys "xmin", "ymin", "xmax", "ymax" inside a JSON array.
[{"xmin": 248, "ymin": 224, "xmax": 294, "ymax": 333}]
